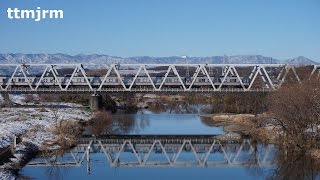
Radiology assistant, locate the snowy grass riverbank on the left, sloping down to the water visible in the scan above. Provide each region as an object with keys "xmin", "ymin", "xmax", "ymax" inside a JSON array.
[{"xmin": 0, "ymin": 96, "xmax": 91, "ymax": 179}]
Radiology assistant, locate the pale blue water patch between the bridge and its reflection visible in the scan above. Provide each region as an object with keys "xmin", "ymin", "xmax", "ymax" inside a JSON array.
[{"xmin": 113, "ymin": 114, "xmax": 223, "ymax": 135}]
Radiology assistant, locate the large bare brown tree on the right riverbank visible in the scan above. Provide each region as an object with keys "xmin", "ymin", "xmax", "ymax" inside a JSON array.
[{"xmin": 269, "ymin": 80, "xmax": 320, "ymax": 151}]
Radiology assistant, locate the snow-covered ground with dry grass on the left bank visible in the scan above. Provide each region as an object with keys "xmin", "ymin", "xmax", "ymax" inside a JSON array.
[{"xmin": 0, "ymin": 95, "xmax": 91, "ymax": 179}]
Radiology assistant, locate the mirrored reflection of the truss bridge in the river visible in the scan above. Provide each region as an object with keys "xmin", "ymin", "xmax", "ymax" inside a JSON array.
[{"xmin": 27, "ymin": 135, "xmax": 275, "ymax": 171}]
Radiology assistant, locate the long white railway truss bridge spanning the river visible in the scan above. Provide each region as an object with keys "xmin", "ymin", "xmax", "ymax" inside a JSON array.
[{"xmin": 0, "ymin": 64, "xmax": 320, "ymax": 94}]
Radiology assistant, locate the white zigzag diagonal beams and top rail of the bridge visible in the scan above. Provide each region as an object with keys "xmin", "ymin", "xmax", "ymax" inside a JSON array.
[{"xmin": 0, "ymin": 64, "xmax": 320, "ymax": 92}]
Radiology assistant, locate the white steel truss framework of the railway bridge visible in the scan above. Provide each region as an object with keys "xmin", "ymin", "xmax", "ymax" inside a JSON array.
[{"xmin": 0, "ymin": 64, "xmax": 320, "ymax": 93}]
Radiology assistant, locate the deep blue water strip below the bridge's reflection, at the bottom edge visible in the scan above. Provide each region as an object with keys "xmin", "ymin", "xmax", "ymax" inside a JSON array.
[{"xmin": 21, "ymin": 153, "xmax": 266, "ymax": 180}]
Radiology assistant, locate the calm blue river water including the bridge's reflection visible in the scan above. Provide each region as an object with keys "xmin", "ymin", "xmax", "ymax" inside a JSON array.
[{"xmin": 20, "ymin": 112, "xmax": 317, "ymax": 180}]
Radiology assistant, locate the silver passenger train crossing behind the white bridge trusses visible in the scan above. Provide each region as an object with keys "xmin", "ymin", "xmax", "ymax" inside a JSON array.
[{"xmin": 0, "ymin": 75, "xmax": 251, "ymax": 88}]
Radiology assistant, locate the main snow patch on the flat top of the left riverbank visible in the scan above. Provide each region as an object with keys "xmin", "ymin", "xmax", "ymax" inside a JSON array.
[{"xmin": 0, "ymin": 108, "xmax": 90, "ymax": 148}]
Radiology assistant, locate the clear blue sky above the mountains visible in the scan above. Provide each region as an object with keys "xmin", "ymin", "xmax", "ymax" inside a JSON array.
[{"xmin": 0, "ymin": 0, "xmax": 320, "ymax": 61}]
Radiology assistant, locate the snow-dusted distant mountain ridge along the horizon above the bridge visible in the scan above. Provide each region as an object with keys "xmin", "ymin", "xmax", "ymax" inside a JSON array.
[{"xmin": 0, "ymin": 53, "xmax": 319, "ymax": 66}]
